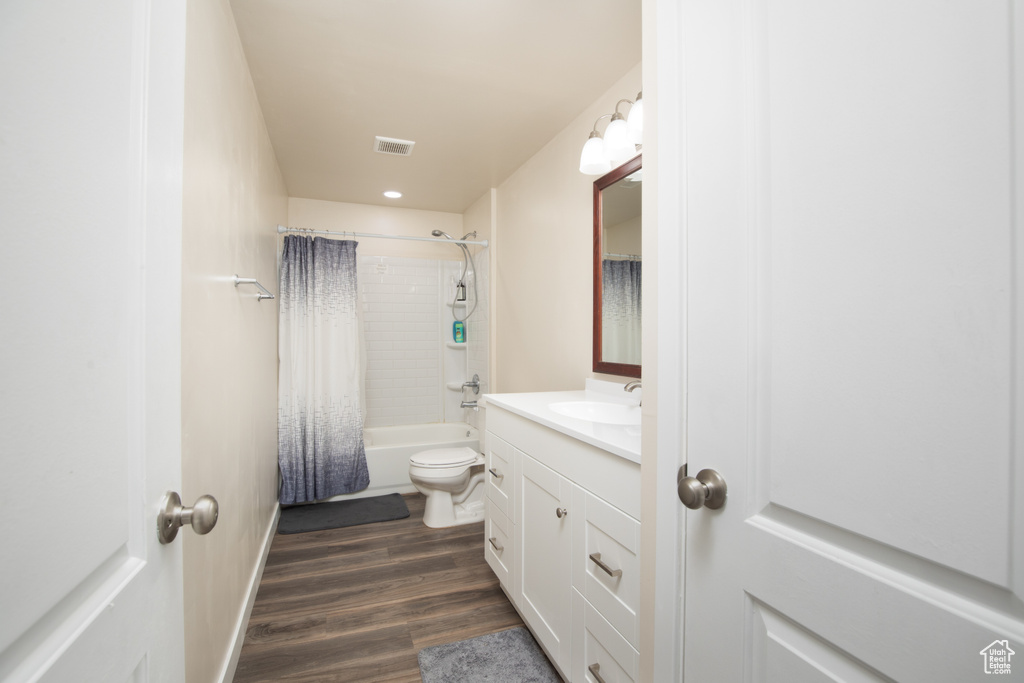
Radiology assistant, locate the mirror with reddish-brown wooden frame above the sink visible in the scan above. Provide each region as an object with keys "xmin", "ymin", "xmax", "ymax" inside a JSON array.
[{"xmin": 594, "ymin": 155, "xmax": 643, "ymax": 378}]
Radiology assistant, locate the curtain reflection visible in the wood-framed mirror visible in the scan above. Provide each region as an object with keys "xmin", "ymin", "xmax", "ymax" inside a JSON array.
[{"xmin": 601, "ymin": 259, "xmax": 643, "ymax": 365}]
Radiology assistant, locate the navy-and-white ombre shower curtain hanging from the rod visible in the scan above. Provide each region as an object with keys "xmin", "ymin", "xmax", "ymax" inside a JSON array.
[{"xmin": 278, "ymin": 236, "xmax": 370, "ymax": 504}]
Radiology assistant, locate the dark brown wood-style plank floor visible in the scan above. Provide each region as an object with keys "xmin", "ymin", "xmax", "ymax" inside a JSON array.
[{"xmin": 234, "ymin": 494, "xmax": 522, "ymax": 683}]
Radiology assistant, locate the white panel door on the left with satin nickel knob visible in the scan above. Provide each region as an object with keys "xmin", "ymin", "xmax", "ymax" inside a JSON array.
[{"xmin": 0, "ymin": 0, "xmax": 188, "ymax": 683}]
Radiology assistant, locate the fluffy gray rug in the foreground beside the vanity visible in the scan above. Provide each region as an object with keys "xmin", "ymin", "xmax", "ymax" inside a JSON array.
[{"xmin": 419, "ymin": 627, "xmax": 562, "ymax": 683}]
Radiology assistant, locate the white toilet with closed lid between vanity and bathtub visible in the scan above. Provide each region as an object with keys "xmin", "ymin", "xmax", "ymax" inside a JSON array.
[{"xmin": 409, "ymin": 446, "xmax": 485, "ymax": 528}]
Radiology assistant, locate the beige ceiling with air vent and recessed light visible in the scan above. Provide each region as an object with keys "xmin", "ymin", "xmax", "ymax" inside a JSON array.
[{"xmin": 231, "ymin": 0, "xmax": 641, "ymax": 213}]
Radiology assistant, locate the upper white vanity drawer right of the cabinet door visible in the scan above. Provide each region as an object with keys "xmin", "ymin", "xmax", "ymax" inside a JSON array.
[{"xmin": 572, "ymin": 488, "xmax": 640, "ymax": 648}]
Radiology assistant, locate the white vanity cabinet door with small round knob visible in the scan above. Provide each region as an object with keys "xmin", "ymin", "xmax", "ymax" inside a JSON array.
[{"xmin": 516, "ymin": 454, "xmax": 573, "ymax": 672}]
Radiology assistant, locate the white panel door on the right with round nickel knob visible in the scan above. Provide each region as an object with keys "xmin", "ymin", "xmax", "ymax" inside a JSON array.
[{"xmin": 679, "ymin": 0, "xmax": 1024, "ymax": 683}]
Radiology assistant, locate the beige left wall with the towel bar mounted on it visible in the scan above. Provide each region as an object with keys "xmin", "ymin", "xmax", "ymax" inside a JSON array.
[{"xmin": 181, "ymin": 0, "xmax": 288, "ymax": 683}]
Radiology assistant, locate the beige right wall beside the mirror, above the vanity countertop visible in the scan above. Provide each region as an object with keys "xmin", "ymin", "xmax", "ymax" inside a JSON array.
[{"xmin": 493, "ymin": 65, "xmax": 640, "ymax": 392}]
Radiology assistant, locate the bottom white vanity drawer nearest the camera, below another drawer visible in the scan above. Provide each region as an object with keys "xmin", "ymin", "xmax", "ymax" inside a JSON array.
[{"xmin": 571, "ymin": 591, "xmax": 640, "ymax": 683}]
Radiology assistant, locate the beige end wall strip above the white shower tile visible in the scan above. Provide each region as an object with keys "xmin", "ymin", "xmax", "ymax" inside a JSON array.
[{"xmin": 282, "ymin": 197, "xmax": 463, "ymax": 261}]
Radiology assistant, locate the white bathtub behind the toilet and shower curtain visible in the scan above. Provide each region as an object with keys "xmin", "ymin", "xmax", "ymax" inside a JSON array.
[{"xmin": 328, "ymin": 422, "xmax": 480, "ymax": 501}]
